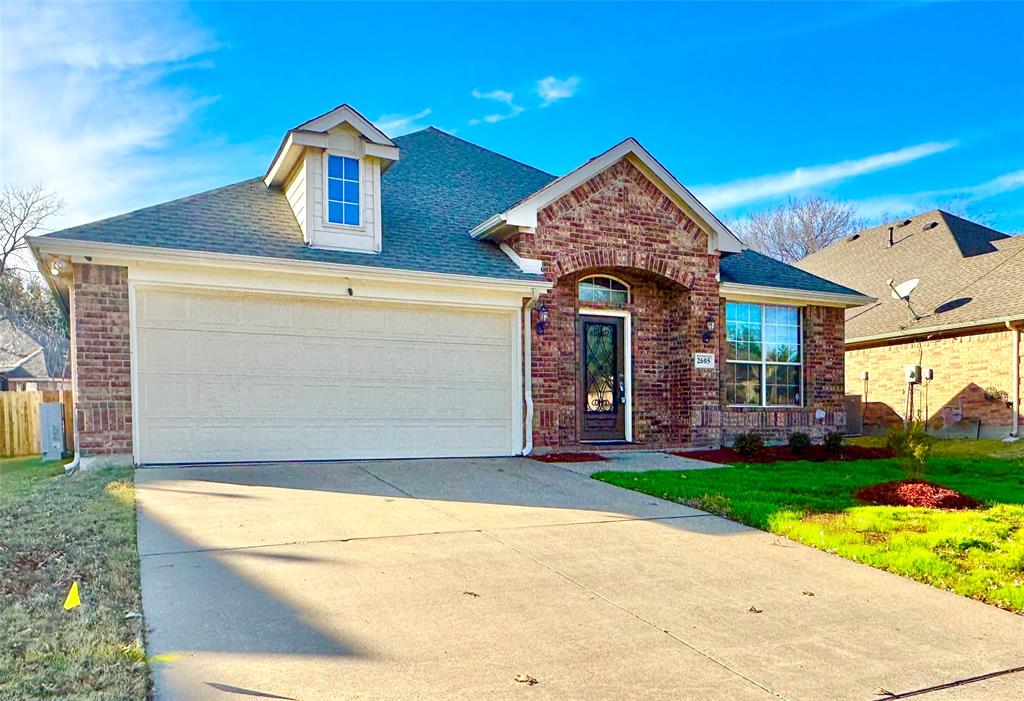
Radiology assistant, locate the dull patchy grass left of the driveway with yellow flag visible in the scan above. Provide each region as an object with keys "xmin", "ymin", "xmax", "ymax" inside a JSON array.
[{"xmin": 0, "ymin": 458, "xmax": 148, "ymax": 701}]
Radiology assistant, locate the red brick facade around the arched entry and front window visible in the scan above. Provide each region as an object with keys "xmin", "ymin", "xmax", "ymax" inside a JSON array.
[{"xmin": 510, "ymin": 160, "xmax": 846, "ymax": 449}]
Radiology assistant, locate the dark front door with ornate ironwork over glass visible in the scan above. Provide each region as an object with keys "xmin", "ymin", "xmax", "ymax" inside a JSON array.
[{"xmin": 579, "ymin": 316, "xmax": 627, "ymax": 441}]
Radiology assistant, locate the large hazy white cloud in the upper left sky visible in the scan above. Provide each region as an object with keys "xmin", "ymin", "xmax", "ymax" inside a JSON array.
[{"xmin": 0, "ymin": 3, "xmax": 251, "ymax": 237}]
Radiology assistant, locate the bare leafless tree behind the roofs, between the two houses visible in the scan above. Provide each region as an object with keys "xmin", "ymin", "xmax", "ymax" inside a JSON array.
[{"xmin": 736, "ymin": 195, "xmax": 864, "ymax": 263}]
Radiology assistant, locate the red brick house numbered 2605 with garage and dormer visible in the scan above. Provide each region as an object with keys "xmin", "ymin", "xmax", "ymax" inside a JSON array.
[{"xmin": 32, "ymin": 105, "xmax": 869, "ymax": 464}]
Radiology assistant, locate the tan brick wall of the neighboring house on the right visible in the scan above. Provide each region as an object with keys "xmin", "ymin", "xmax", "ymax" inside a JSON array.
[{"xmin": 846, "ymin": 330, "xmax": 1019, "ymax": 436}]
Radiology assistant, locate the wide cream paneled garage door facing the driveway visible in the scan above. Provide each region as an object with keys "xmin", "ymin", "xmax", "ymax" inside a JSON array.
[{"xmin": 135, "ymin": 288, "xmax": 519, "ymax": 464}]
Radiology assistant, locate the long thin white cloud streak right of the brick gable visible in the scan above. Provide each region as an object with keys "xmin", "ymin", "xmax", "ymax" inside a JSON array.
[{"xmin": 694, "ymin": 141, "xmax": 956, "ymax": 209}]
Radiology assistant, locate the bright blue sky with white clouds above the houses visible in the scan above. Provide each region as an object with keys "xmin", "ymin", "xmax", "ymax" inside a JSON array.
[{"xmin": 0, "ymin": 2, "xmax": 1024, "ymax": 232}]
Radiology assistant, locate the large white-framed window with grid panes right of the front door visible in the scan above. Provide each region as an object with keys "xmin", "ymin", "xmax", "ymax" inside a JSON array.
[{"xmin": 723, "ymin": 302, "xmax": 803, "ymax": 406}]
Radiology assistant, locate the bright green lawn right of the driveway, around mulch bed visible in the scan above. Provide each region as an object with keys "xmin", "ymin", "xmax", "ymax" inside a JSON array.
[{"xmin": 594, "ymin": 439, "xmax": 1024, "ymax": 613}]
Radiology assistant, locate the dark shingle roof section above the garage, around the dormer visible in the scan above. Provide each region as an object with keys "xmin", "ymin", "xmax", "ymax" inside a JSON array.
[{"xmin": 36, "ymin": 127, "xmax": 554, "ymax": 279}]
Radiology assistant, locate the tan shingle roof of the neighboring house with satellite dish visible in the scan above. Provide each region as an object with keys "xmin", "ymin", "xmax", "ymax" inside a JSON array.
[{"xmin": 797, "ymin": 210, "xmax": 1024, "ymax": 342}]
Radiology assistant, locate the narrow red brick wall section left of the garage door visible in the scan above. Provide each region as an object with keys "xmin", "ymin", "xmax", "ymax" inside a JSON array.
[{"xmin": 71, "ymin": 265, "xmax": 132, "ymax": 457}]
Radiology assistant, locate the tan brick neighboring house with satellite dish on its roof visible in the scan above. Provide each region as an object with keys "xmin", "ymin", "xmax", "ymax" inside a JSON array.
[{"xmin": 797, "ymin": 210, "xmax": 1024, "ymax": 436}]
